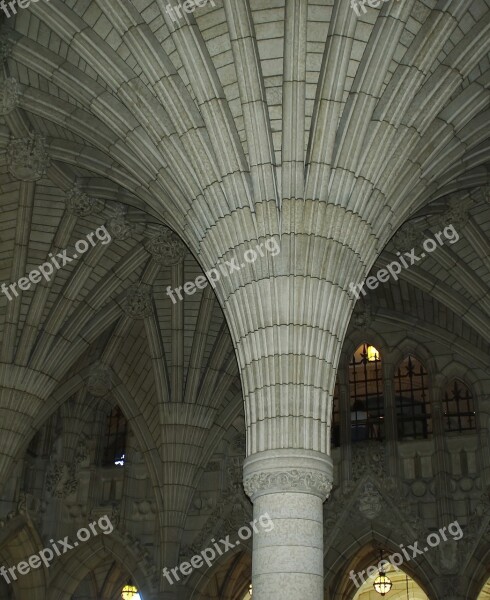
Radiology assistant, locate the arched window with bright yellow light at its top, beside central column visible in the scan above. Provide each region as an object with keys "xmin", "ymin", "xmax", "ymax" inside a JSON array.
[{"xmin": 349, "ymin": 343, "xmax": 384, "ymax": 442}]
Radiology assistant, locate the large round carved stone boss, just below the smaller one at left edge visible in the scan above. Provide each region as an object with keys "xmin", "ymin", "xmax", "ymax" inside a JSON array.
[{"xmin": 7, "ymin": 132, "xmax": 50, "ymax": 181}]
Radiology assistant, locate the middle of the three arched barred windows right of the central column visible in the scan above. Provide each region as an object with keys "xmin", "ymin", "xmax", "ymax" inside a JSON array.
[{"xmin": 395, "ymin": 354, "xmax": 432, "ymax": 440}]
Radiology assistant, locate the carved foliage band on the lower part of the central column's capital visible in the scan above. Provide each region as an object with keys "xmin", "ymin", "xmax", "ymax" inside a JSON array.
[{"xmin": 243, "ymin": 469, "xmax": 332, "ymax": 499}]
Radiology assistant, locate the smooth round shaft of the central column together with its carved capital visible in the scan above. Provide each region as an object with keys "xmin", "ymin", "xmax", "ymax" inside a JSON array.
[{"xmin": 244, "ymin": 449, "xmax": 333, "ymax": 600}]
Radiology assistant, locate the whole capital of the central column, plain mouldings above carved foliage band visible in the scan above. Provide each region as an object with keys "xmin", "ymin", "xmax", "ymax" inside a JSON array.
[{"xmin": 243, "ymin": 449, "xmax": 333, "ymax": 502}]
